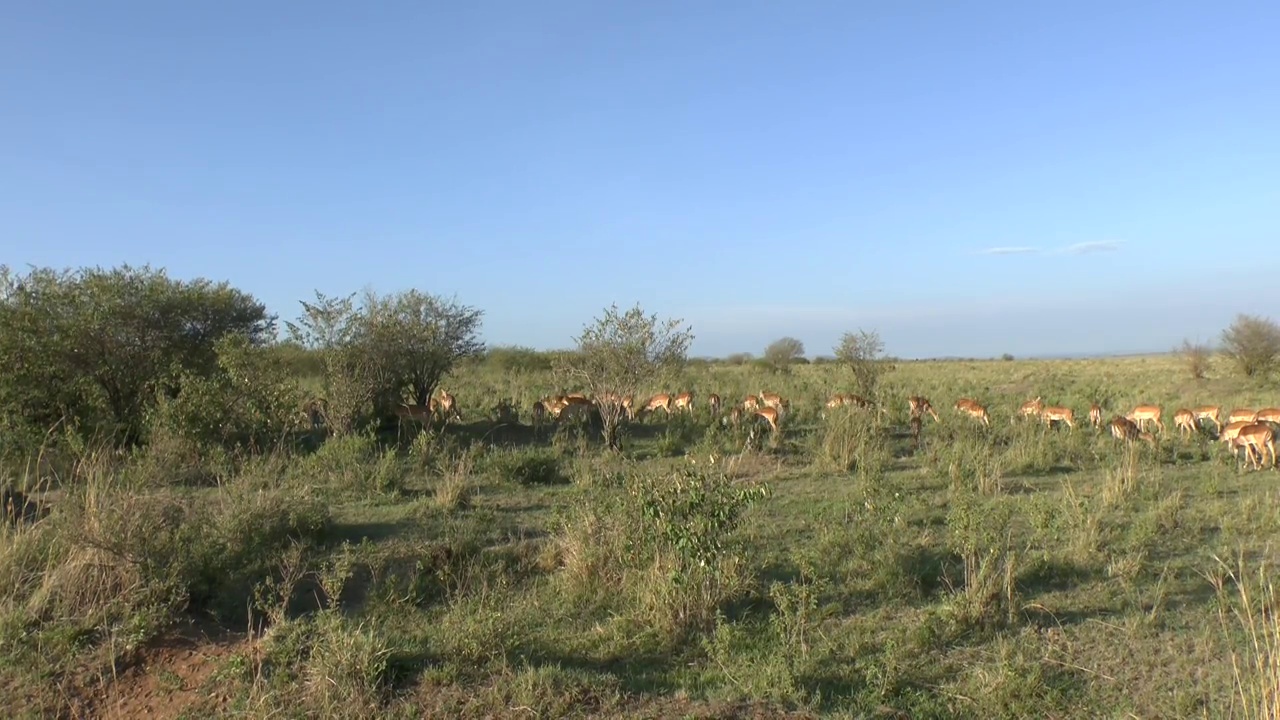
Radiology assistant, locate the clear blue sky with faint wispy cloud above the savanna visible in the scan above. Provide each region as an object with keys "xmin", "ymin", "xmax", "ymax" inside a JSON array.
[{"xmin": 0, "ymin": 0, "xmax": 1280, "ymax": 356}]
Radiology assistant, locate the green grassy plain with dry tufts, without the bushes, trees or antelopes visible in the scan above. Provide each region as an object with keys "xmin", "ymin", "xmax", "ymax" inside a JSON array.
[{"xmin": 0, "ymin": 356, "xmax": 1280, "ymax": 719}]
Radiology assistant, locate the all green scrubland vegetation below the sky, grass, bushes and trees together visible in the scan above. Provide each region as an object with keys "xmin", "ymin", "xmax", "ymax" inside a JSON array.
[{"xmin": 0, "ymin": 268, "xmax": 1280, "ymax": 719}]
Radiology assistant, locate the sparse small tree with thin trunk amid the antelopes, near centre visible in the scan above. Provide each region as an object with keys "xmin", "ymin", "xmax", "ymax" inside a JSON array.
[{"xmin": 556, "ymin": 304, "xmax": 694, "ymax": 450}]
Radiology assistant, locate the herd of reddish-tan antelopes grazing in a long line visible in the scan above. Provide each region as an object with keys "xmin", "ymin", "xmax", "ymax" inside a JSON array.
[{"xmin": 330, "ymin": 389, "xmax": 1280, "ymax": 469}]
